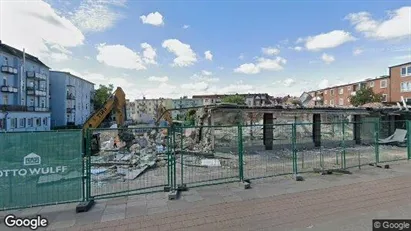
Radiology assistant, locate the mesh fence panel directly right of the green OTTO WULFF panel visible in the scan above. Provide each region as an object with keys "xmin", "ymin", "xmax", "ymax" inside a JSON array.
[{"xmin": 88, "ymin": 127, "xmax": 170, "ymax": 199}]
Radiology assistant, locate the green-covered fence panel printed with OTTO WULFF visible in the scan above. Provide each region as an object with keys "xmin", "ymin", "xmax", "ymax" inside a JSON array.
[{"xmin": 0, "ymin": 130, "xmax": 83, "ymax": 209}]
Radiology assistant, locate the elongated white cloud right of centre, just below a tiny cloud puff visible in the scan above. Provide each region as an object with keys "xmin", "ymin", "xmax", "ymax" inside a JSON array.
[{"xmin": 234, "ymin": 57, "xmax": 287, "ymax": 74}]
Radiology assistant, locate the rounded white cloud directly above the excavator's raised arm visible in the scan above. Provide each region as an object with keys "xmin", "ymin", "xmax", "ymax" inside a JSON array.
[{"xmin": 97, "ymin": 43, "xmax": 146, "ymax": 70}]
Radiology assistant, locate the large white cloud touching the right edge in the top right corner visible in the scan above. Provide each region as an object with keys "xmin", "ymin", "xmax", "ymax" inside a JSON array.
[{"xmin": 345, "ymin": 6, "xmax": 411, "ymax": 40}]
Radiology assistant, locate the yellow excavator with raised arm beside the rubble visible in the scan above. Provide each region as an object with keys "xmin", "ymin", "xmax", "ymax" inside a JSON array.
[{"xmin": 83, "ymin": 87, "xmax": 126, "ymax": 154}]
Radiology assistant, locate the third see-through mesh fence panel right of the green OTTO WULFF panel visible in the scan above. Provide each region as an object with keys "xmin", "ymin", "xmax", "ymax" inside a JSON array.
[{"xmin": 242, "ymin": 124, "xmax": 293, "ymax": 179}]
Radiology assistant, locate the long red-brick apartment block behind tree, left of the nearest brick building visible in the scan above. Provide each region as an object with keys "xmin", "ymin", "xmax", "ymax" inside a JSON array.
[{"xmin": 309, "ymin": 76, "xmax": 391, "ymax": 106}]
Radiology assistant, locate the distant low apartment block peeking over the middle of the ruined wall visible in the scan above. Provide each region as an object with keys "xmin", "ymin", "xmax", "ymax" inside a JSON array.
[{"xmin": 193, "ymin": 93, "xmax": 272, "ymax": 107}]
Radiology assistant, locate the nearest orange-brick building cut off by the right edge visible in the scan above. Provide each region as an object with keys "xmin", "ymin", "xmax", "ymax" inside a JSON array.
[{"xmin": 389, "ymin": 62, "xmax": 411, "ymax": 103}]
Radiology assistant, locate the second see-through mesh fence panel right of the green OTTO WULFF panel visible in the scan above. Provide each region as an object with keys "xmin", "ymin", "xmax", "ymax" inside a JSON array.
[{"xmin": 172, "ymin": 126, "xmax": 240, "ymax": 187}]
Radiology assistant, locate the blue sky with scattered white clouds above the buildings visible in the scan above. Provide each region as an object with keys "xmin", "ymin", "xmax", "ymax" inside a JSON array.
[{"xmin": 0, "ymin": 0, "xmax": 411, "ymax": 100}]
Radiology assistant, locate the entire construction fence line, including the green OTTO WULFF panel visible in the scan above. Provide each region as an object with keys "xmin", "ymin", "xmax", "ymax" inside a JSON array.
[{"xmin": 0, "ymin": 118, "xmax": 411, "ymax": 210}]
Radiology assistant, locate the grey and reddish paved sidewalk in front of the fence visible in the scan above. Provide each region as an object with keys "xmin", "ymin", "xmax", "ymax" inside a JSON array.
[{"xmin": 0, "ymin": 162, "xmax": 411, "ymax": 231}]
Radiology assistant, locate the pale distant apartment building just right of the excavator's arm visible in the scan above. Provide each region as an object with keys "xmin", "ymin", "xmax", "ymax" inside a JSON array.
[{"xmin": 126, "ymin": 97, "xmax": 172, "ymax": 123}]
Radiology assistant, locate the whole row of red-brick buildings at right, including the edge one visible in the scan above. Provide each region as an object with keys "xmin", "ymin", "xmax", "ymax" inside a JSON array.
[{"xmin": 308, "ymin": 62, "xmax": 411, "ymax": 106}]
